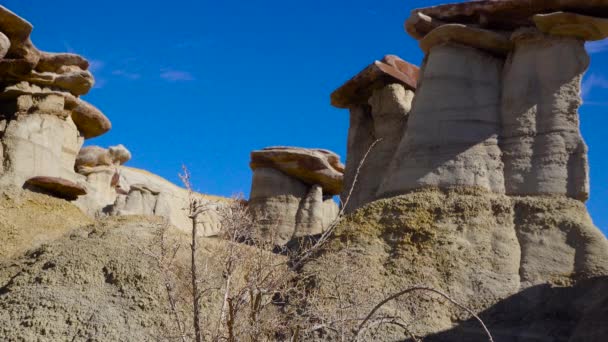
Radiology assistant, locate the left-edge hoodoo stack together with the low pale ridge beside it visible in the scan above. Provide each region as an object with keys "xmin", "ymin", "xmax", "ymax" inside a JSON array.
[{"xmin": 0, "ymin": 6, "xmax": 222, "ymax": 236}]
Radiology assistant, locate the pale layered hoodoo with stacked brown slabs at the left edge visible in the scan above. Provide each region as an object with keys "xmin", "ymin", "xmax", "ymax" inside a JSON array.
[{"xmin": 0, "ymin": 6, "xmax": 111, "ymax": 191}]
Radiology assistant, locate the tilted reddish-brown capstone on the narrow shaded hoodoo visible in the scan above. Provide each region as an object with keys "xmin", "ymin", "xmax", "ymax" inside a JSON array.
[{"xmin": 331, "ymin": 55, "xmax": 420, "ymax": 108}]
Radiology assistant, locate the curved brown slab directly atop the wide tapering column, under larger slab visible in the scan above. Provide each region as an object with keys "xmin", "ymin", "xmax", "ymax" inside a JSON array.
[{"xmin": 420, "ymin": 24, "xmax": 513, "ymax": 55}]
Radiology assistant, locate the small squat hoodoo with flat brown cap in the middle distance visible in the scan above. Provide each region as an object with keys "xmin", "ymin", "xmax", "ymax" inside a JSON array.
[{"xmin": 249, "ymin": 147, "xmax": 344, "ymax": 245}]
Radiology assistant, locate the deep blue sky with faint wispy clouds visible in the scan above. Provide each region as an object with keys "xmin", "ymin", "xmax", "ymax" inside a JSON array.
[{"xmin": 3, "ymin": 0, "xmax": 608, "ymax": 232}]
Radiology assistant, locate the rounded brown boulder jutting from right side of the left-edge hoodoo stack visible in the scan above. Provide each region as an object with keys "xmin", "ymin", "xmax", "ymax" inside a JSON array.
[{"xmin": 66, "ymin": 99, "xmax": 112, "ymax": 139}]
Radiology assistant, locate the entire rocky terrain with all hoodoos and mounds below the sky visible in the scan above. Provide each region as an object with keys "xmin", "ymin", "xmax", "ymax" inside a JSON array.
[{"xmin": 0, "ymin": 0, "xmax": 608, "ymax": 342}]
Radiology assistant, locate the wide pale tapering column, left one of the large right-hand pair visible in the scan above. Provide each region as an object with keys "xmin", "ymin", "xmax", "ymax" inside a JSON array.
[{"xmin": 377, "ymin": 43, "xmax": 504, "ymax": 197}]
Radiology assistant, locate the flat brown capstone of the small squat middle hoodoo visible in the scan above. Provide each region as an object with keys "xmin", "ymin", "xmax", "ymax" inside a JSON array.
[{"xmin": 250, "ymin": 147, "xmax": 344, "ymax": 195}]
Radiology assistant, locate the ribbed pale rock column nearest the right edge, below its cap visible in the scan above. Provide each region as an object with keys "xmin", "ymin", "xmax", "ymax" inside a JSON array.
[{"xmin": 501, "ymin": 29, "xmax": 589, "ymax": 201}]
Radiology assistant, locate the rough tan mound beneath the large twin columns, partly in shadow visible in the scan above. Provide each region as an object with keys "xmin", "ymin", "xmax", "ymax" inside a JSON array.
[{"xmin": 304, "ymin": 188, "xmax": 608, "ymax": 341}]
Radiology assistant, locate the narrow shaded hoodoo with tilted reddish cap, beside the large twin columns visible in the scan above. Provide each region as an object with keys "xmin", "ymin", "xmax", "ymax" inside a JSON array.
[{"xmin": 331, "ymin": 55, "xmax": 418, "ymax": 212}]
